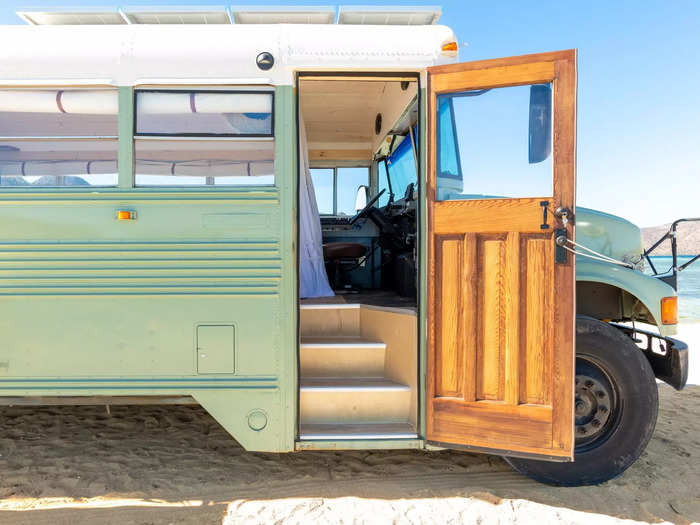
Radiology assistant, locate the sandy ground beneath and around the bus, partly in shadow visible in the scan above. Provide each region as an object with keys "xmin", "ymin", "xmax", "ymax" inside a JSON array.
[{"xmin": 0, "ymin": 323, "xmax": 700, "ymax": 525}]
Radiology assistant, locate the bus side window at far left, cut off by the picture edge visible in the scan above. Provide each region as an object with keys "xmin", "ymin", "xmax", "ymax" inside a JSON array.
[{"xmin": 0, "ymin": 89, "xmax": 118, "ymax": 189}]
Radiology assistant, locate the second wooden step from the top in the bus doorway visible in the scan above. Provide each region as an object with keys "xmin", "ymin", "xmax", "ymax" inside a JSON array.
[{"xmin": 300, "ymin": 336, "xmax": 386, "ymax": 378}]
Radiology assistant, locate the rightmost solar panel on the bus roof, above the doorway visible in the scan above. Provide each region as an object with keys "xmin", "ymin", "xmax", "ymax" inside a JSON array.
[{"xmin": 338, "ymin": 6, "xmax": 442, "ymax": 25}]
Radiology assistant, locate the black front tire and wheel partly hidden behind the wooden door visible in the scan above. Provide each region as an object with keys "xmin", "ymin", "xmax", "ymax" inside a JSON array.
[{"xmin": 506, "ymin": 317, "xmax": 659, "ymax": 487}]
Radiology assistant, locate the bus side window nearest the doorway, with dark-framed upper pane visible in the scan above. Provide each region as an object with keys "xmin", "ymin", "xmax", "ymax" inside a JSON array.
[{"xmin": 134, "ymin": 90, "xmax": 275, "ymax": 186}]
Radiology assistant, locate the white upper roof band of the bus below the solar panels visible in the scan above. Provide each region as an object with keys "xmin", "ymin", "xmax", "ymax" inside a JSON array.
[{"xmin": 0, "ymin": 24, "xmax": 456, "ymax": 86}]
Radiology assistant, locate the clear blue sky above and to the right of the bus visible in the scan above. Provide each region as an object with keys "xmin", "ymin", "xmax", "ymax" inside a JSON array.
[{"xmin": 0, "ymin": 0, "xmax": 700, "ymax": 226}]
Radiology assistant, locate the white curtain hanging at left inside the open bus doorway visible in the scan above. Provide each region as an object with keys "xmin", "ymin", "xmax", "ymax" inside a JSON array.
[{"xmin": 299, "ymin": 114, "xmax": 334, "ymax": 298}]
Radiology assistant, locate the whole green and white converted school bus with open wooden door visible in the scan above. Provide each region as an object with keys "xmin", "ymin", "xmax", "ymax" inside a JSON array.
[{"xmin": 0, "ymin": 8, "xmax": 687, "ymax": 484}]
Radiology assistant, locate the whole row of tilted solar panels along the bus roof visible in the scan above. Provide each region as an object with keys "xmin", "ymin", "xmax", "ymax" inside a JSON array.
[{"xmin": 17, "ymin": 6, "xmax": 442, "ymax": 25}]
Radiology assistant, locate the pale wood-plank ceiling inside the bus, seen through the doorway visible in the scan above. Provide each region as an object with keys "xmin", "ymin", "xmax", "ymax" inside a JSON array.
[{"xmin": 300, "ymin": 79, "xmax": 417, "ymax": 162}]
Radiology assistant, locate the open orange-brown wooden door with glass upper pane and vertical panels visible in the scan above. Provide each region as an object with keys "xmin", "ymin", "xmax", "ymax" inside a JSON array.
[{"xmin": 426, "ymin": 50, "xmax": 576, "ymax": 461}]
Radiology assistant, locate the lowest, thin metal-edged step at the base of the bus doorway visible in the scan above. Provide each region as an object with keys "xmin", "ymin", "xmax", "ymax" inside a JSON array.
[{"xmin": 299, "ymin": 423, "xmax": 418, "ymax": 441}]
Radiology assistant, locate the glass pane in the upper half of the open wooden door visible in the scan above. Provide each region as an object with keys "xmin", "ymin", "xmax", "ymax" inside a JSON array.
[{"xmin": 436, "ymin": 84, "xmax": 552, "ymax": 200}]
